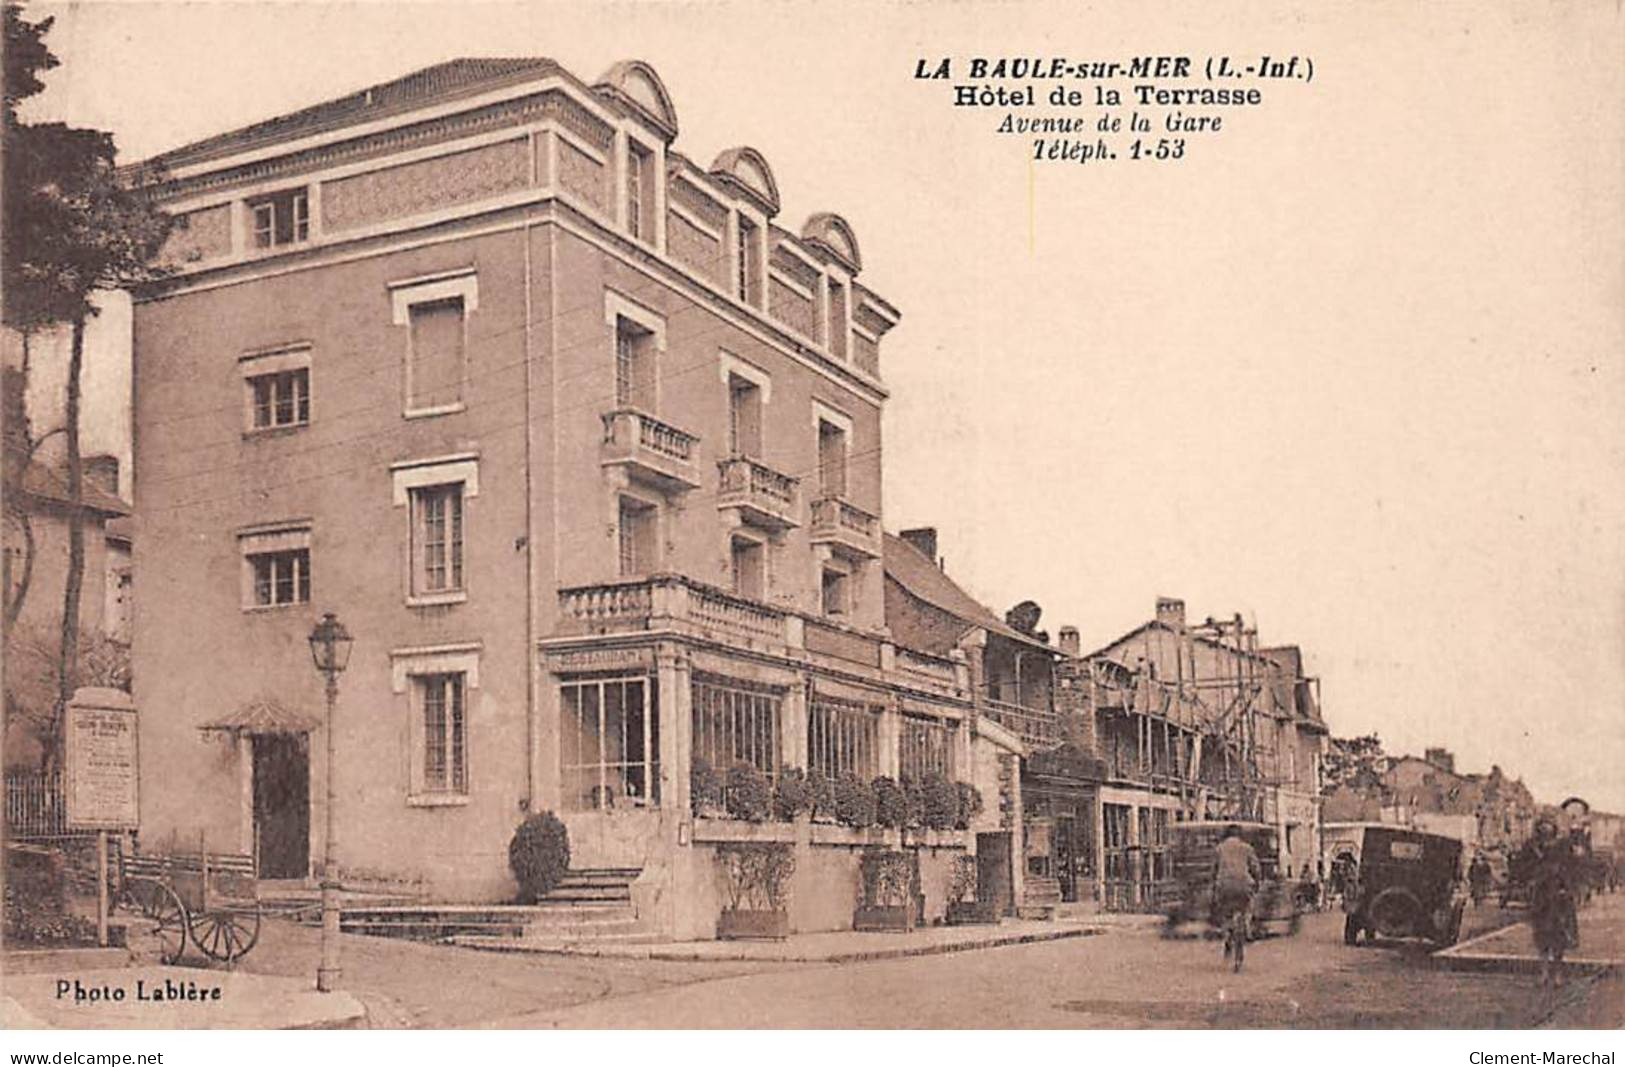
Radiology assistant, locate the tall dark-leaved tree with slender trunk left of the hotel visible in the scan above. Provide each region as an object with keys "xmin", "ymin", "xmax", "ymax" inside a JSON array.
[{"xmin": 0, "ymin": 5, "xmax": 171, "ymax": 763}]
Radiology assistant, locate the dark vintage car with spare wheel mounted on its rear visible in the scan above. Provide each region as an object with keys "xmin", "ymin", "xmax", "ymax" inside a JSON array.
[{"xmin": 1342, "ymin": 827, "xmax": 1467, "ymax": 945}]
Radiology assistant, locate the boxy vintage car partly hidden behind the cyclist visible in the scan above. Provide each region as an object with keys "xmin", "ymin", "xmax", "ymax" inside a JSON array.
[{"xmin": 1165, "ymin": 822, "xmax": 1302, "ymax": 939}]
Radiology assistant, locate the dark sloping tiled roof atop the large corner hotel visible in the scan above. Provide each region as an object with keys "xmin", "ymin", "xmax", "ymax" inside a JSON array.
[{"xmin": 153, "ymin": 57, "xmax": 559, "ymax": 167}]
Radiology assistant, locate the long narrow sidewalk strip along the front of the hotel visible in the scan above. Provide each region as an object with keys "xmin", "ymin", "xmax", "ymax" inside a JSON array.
[{"xmin": 450, "ymin": 919, "xmax": 1103, "ymax": 963}]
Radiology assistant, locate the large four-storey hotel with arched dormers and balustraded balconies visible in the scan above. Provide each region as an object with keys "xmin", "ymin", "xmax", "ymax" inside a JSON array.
[{"xmin": 135, "ymin": 58, "xmax": 1011, "ymax": 937}]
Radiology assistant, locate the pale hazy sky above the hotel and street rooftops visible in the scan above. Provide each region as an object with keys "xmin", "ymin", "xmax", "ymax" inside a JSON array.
[{"xmin": 15, "ymin": 0, "xmax": 1625, "ymax": 810}]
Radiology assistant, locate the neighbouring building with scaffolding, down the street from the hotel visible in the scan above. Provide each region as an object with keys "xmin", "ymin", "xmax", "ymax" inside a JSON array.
[{"xmin": 1060, "ymin": 598, "xmax": 1328, "ymax": 909}]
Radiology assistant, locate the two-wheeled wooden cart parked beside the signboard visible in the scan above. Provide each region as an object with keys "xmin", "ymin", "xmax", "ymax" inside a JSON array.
[{"xmin": 119, "ymin": 848, "xmax": 260, "ymax": 963}]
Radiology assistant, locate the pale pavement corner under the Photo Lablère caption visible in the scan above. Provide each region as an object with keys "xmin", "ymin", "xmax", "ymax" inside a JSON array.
[{"xmin": 0, "ymin": 966, "xmax": 367, "ymax": 1030}]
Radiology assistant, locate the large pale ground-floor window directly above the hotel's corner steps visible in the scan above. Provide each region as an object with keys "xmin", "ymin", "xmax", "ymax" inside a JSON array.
[{"xmin": 559, "ymin": 677, "xmax": 660, "ymax": 810}]
